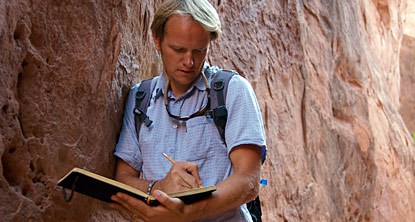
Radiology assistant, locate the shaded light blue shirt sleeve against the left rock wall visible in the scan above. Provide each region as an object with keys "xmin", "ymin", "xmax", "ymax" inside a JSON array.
[{"xmin": 114, "ymin": 84, "xmax": 143, "ymax": 172}]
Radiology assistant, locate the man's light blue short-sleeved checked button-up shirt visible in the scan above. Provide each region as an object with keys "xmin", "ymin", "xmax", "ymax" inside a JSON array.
[{"xmin": 114, "ymin": 67, "xmax": 265, "ymax": 221}]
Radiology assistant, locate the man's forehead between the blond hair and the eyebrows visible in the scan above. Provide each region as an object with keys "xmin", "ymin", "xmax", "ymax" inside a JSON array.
[{"xmin": 163, "ymin": 15, "xmax": 210, "ymax": 48}]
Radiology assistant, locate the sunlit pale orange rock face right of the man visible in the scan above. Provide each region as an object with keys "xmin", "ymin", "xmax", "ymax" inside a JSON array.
[{"xmin": 217, "ymin": 1, "xmax": 415, "ymax": 221}]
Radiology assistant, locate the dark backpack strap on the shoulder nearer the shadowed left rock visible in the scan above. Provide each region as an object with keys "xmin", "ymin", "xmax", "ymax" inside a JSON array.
[{"xmin": 133, "ymin": 78, "xmax": 158, "ymax": 138}]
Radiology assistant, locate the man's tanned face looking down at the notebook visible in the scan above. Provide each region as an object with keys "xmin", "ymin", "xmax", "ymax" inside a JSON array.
[{"xmin": 153, "ymin": 15, "xmax": 210, "ymax": 97}]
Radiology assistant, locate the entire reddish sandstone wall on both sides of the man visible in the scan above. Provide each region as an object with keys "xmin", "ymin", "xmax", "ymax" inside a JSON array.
[{"xmin": 0, "ymin": 0, "xmax": 415, "ymax": 221}]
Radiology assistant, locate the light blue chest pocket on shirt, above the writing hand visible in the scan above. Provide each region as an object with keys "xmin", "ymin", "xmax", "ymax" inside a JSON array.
[{"xmin": 184, "ymin": 116, "xmax": 227, "ymax": 163}]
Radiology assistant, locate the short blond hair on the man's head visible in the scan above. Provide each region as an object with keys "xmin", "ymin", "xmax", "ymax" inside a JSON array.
[{"xmin": 151, "ymin": 0, "xmax": 222, "ymax": 40}]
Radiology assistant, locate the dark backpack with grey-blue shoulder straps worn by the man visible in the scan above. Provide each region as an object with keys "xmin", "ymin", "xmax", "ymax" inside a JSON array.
[{"xmin": 133, "ymin": 68, "xmax": 266, "ymax": 222}]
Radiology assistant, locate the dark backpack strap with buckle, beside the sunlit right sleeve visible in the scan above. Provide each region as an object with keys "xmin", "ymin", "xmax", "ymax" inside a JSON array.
[{"xmin": 209, "ymin": 70, "xmax": 237, "ymax": 141}]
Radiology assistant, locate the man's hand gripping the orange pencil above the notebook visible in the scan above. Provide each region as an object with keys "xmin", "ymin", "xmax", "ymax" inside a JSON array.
[{"xmin": 153, "ymin": 162, "xmax": 202, "ymax": 193}]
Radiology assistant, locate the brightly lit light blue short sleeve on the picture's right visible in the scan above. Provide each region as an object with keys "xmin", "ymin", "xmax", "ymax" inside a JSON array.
[{"xmin": 225, "ymin": 75, "xmax": 266, "ymax": 153}]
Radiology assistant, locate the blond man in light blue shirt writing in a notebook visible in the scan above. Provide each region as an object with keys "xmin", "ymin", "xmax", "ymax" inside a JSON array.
[{"xmin": 112, "ymin": 0, "xmax": 265, "ymax": 221}]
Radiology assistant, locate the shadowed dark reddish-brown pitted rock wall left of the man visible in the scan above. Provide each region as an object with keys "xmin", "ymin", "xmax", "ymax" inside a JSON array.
[{"xmin": 0, "ymin": 0, "xmax": 157, "ymax": 221}]
